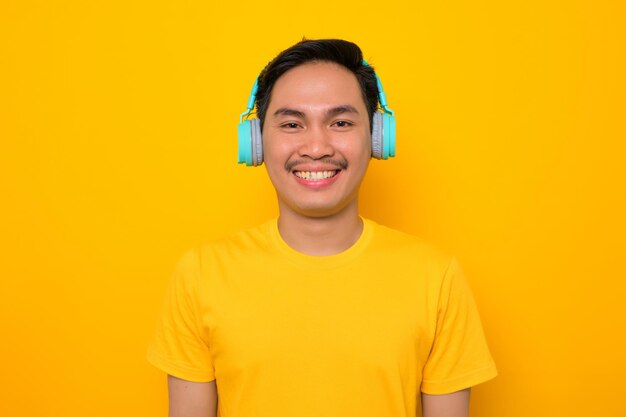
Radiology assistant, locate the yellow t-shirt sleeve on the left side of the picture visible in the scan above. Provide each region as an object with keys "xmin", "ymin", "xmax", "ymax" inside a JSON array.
[{"xmin": 148, "ymin": 251, "xmax": 215, "ymax": 382}]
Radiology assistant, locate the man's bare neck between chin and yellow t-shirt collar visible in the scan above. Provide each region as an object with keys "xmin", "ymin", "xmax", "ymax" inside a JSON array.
[{"xmin": 278, "ymin": 204, "xmax": 363, "ymax": 256}]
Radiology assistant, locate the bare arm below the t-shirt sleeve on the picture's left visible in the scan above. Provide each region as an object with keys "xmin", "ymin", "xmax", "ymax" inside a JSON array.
[{"xmin": 167, "ymin": 375, "xmax": 217, "ymax": 417}]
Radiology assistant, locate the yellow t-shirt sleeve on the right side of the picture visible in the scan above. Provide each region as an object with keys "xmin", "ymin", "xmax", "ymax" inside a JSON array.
[{"xmin": 421, "ymin": 259, "xmax": 497, "ymax": 395}]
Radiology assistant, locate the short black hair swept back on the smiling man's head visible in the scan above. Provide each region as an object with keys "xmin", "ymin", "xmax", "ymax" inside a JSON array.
[{"xmin": 256, "ymin": 39, "xmax": 378, "ymax": 128}]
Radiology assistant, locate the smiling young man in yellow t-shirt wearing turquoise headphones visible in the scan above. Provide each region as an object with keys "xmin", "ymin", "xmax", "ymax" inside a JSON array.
[{"xmin": 148, "ymin": 40, "xmax": 496, "ymax": 417}]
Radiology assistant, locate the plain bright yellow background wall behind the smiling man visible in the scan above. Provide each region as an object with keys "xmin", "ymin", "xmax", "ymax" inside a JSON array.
[{"xmin": 0, "ymin": 0, "xmax": 626, "ymax": 417}]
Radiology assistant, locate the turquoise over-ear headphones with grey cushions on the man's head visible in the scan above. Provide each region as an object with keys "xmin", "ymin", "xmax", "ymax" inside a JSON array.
[{"xmin": 238, "ymin": 60, "xmax": 396, "ymax": 166}]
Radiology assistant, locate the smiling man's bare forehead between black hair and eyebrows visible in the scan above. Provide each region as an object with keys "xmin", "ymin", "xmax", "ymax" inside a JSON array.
[{"xmin": 268, "ymin": 62, "xmax": 366, "ymax": 114}]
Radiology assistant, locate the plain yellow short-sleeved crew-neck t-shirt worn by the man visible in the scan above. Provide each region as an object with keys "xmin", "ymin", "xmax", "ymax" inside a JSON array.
[{"xmin": 148, "ymin": 220, "xmax": 496, "ymax": 417}]
